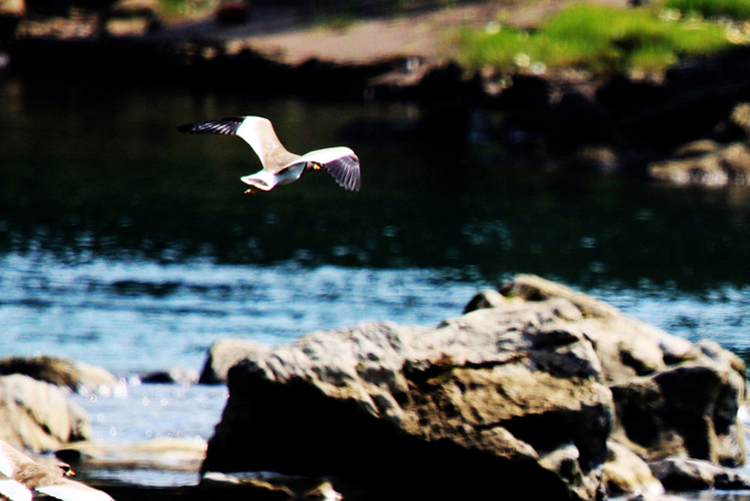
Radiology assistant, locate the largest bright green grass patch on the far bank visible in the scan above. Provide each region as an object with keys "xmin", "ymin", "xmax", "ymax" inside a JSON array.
[{"xmin": 458, "ymin": 5, "xmax": 731, "ymax": 74}]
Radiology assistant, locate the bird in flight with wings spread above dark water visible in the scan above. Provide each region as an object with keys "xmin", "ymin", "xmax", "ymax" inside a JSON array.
[{"xmin": 177, "ymin": 116, "xmax": 360, "ymax": 193}]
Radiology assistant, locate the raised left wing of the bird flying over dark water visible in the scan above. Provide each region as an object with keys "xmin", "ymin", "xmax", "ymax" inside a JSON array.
[{"xmin": 177, "ymin": 116, "xmax": 298, "ymax": 172}]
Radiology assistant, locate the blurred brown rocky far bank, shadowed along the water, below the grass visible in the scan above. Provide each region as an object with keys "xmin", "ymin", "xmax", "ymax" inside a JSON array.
[{"xmin": 0, "ymin": 0, "xmax": 750, "ymax": 187}]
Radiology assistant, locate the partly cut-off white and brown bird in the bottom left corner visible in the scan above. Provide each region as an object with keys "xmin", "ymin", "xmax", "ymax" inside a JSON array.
[{"xmin": 0, "ymin": 440, "xmax": 114, "ymax": 501}]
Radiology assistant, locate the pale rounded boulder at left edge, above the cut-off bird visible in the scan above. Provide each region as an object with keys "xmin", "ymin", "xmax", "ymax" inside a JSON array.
[{"xmin": 0, "ymin": 374, "xmax": 91, "ymax": 452}]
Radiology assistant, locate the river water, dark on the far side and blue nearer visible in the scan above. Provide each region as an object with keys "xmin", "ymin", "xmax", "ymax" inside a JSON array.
[{"xmin": 0, "ymin": 76, "xmax": 750, "ymax": 488}]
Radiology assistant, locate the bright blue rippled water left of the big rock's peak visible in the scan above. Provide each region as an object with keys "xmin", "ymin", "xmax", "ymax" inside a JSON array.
[{"xmin": 0, "ymin": 255, "xmax": 477, "ymax": 375}]
